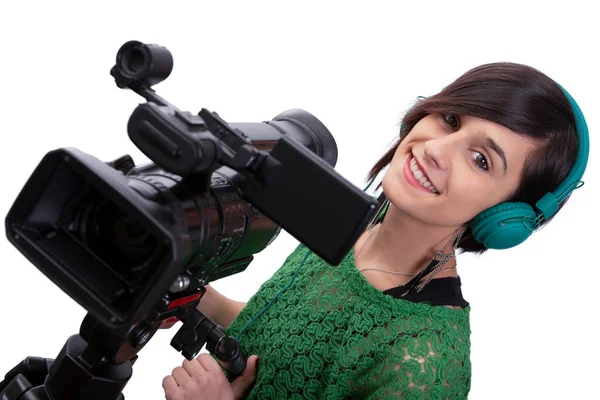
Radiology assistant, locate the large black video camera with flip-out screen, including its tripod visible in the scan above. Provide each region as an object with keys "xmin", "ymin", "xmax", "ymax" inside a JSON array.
[{"xmin": 0, "ymin": 41, "xmax": 377, "ymax": 400}]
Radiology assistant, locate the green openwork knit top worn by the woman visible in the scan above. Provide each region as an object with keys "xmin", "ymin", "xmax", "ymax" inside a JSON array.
[{"xmin": 227, "ymin": 244, "xmax": 471, "ymax": 400}]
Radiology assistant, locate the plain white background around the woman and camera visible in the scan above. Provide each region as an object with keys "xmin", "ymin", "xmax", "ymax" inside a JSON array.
[{"xmin": 0, "ymin": 0, "xmax": 600, "ymax": 400}]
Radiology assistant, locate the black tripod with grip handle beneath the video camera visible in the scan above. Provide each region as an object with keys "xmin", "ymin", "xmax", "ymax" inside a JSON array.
[{"xmin": 0, "ymin": 308, "xmax": 246, "ymax": 400}]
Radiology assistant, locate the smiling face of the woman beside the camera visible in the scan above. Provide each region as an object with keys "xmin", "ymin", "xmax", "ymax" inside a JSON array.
[{"xmin": 382, "ymin": 114, "xmax": 536, "ymax": 227}]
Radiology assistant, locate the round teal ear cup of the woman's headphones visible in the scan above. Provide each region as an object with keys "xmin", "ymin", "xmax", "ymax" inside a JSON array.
[{"xmin": 471, "ymin": 203, "xmax": 537, "ymax": 250}]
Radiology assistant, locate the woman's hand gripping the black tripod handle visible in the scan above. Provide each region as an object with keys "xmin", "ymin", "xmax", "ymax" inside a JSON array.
[{"xmin": 163, "ymin": 353, "xmax": 258, "ymax": 400}]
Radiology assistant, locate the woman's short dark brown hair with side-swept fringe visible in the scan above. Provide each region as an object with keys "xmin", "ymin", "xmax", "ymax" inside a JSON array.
[{"xmin": 367, "ymin": 62, "xmax": 578, "ymax": 253}]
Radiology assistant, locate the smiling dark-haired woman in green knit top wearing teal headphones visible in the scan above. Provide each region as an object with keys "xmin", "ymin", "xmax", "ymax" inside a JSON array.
[{"xmin": 163, "ymin": 63, "xmax": 587, "ymax": 399}]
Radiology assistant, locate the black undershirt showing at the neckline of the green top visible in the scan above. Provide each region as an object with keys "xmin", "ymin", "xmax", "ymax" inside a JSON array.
[{"xmin": 383, "ymin": 277, "xmax": 469, "ymax": 307}]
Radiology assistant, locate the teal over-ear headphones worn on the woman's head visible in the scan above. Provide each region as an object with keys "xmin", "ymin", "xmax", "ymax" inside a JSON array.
[{"xmin": 471, "ymin": 85, "xmax": 590, "ymax": 249}]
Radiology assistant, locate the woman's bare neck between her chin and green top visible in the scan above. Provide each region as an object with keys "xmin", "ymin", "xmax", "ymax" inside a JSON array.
[{"xmin": 354, "ymin": 204, "xmax": 460, "ymax": 287}]
